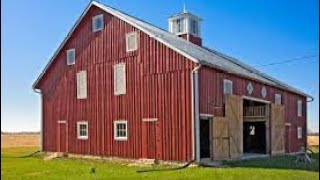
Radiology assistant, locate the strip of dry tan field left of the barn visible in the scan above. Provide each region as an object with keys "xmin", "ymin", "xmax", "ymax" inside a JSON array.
[{"xmin": 1, "ymin": 133, "xmax": 40, "ymax": 148}]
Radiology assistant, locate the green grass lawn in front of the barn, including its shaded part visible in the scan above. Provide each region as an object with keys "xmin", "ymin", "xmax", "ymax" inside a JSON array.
[{"xmin": 1, "ymin": 147, "xmax": 319, "ymax": 180}]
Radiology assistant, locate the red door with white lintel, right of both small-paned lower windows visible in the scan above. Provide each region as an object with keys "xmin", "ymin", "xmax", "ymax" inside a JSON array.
[{"xmin": 142, "ymin": 119, "xmax": 162, "ymax": 159}]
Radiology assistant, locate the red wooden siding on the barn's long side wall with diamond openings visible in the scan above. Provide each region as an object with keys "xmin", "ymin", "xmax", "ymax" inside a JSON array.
[{"xmin": 199, "ymin": 66, "xmax": 307, "ymax": 152}]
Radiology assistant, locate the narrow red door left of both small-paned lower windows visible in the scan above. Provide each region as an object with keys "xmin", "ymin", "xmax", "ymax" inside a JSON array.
[{"xmin": 57, "ymin": 121, "xmax": 67, "ymax": 152}]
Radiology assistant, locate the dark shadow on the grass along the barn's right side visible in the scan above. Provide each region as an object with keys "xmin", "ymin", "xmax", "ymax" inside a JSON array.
[{"xmin": 224, "ymin": 152, "xmax": 319, "ymax": 172}]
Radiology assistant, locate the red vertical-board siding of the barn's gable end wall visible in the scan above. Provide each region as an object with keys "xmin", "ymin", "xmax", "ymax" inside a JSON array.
[{"xmin": 38, "ymin": 6, "xmax": 195, "ymax": 161}]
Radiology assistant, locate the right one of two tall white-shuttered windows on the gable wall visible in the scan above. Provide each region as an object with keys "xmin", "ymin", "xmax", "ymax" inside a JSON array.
[{"xmin": 113, "ymin": 63, "xmax": 126, "ymax": 95}]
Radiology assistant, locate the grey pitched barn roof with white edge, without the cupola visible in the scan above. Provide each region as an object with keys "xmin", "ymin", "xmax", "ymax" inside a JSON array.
[{"xmin": 33, "ymin": 1, "xmax": 312, "ymax": 98}]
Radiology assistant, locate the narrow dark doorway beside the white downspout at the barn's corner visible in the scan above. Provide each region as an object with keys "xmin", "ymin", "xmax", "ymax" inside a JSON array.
[{"xmin": 200, "ymin": 120, "xmax": 210, "ymax": 158}]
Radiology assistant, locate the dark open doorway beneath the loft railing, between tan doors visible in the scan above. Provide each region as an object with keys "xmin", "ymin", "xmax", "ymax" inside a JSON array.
[{"xmin": 243, "ymin": 122, "xmax": 266, "ymax": 154}]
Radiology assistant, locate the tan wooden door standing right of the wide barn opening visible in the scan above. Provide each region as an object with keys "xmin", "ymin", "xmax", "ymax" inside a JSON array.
[{"xmin": 271, "ymin": 104, "xmax": 285, "ymax": 155}]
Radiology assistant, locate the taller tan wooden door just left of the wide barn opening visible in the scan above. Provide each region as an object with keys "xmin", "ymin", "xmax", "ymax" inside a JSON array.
[{"xmin": 225, "ymin": 95, "xmax": 243, "ymax": 159}]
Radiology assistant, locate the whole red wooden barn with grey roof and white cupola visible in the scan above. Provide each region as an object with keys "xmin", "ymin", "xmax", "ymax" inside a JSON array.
[{"xmin": 33, "ymin": 1, "xmax": 312, "ymax": 161}]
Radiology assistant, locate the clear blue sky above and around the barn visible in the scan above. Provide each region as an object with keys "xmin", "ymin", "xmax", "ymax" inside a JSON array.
[{"xmin": 1, "ymin": 0, "xmax": 319, "ymax": 132}]
